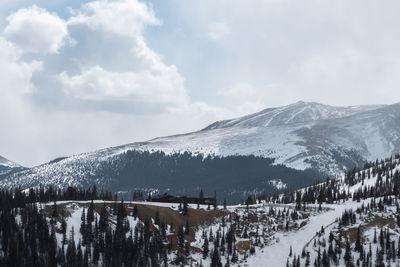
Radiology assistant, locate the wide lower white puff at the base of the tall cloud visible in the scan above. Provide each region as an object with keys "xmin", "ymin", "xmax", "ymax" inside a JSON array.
[{"xmin": 59, "ymin": 66, "xmax": 187, "ymax": 107}]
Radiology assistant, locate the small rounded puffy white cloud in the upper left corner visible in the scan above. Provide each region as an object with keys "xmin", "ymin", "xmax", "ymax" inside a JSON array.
[{"xmin": 4, "ymin": 5, "xmax": 69, "ymax": 54}]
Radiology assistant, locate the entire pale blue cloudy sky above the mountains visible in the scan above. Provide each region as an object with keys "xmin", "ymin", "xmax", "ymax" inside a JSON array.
[{"xmin": 0, "ymin": 0, "xmax": 400, "ymax": 166}]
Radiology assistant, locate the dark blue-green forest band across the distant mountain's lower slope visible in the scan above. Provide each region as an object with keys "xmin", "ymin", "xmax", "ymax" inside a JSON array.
[{"xmin": 97, "ymin": 151, "xmax": 323, "ymax": 203}]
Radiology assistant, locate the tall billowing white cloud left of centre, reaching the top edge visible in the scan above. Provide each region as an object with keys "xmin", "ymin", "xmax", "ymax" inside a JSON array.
[{"xmin": 52, "ymin": 0, "xmax": 189, "ymax": 112}]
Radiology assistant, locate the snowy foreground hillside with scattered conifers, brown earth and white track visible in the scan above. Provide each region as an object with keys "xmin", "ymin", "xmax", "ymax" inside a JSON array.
[{"xmin": 15, "ymin": 155, "xmax": 400, "ymax": 267}]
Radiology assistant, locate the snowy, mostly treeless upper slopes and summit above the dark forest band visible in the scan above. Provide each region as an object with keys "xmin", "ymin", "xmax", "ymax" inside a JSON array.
[{"xmin": 134, "ymin": 102, "xmax": 400, "ymax": 175}]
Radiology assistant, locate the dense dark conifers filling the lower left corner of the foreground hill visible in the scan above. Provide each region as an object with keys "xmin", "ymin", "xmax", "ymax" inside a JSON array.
[{"xmin": 0, "ymin": 188, "xmax": 171, "ymax": 267}]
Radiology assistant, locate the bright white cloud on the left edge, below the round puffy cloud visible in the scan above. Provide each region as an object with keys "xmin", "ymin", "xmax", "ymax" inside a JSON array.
[{"xmin": 0, "ymin": 37, "xmax": 42, "ymax": 165}]
